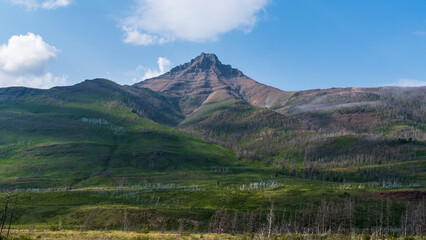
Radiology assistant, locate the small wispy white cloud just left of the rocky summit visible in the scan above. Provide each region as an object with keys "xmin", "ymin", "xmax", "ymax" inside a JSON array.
[{"xmin": 126, "ymin": 57, "xmax": 172, "ymax": 82}]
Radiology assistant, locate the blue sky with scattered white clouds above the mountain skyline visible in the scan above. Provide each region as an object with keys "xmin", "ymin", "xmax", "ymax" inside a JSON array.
[{"xmin": 0, "ymin": 0, "xmax": 426, "ymax": 90}]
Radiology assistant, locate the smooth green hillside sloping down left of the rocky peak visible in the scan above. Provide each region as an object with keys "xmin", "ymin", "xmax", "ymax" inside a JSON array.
[{"xmin": 0, "ymin": 80, "xmax": 235, "ymax": 189}]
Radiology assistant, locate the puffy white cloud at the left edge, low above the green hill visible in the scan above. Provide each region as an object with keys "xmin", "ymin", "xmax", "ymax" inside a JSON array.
[{"xmin": 0, "ymin": 33, "xmax": 67, "ymax": 88}]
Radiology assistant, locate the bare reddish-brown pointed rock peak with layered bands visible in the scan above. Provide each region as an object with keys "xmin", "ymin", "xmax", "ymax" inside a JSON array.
[{"xmin": 136, "ymin": 53, "xmax": 283, "ymax": 114}]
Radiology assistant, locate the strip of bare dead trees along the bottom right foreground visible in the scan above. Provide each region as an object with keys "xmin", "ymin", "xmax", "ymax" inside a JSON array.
[{"xmin": 208, "ymin": 198, "xmax": 426, "ymax": 236}]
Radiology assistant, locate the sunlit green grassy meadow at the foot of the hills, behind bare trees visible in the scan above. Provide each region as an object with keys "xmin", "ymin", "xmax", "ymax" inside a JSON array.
[{"xmin": 0, "ymin": 173, "xmax": 423, "ymax": 231}]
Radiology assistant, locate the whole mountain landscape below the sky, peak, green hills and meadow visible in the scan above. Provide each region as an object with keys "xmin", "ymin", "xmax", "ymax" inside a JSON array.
[{"xmin": 0, "ymin": 53, "xmax": 426, "ymax": 239}]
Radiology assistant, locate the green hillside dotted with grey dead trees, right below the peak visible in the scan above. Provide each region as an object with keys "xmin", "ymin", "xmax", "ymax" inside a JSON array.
[{"xmin": 179, "ymin": 90, "xmax": 426, "ymax": 186}]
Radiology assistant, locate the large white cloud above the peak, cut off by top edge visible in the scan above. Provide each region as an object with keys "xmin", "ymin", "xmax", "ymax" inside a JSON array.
[{"xmin": 122, "ymin": 0, "xmax": 270, "ymax": 45}]
